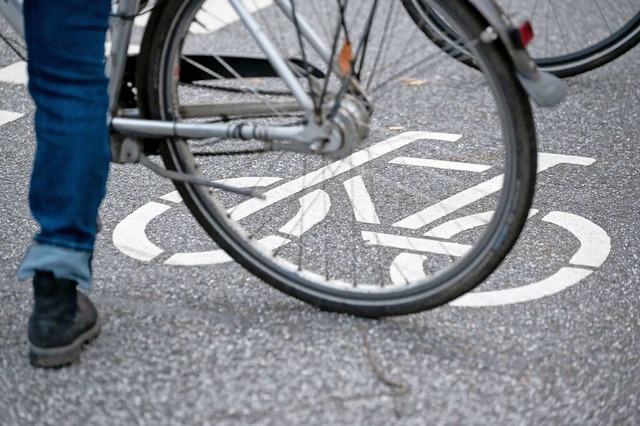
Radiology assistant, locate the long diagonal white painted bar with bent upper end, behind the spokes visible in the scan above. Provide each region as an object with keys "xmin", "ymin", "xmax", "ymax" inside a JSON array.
[{"xmin": 230, "ymin": 132, "xmax": 460, "ymax": 220}]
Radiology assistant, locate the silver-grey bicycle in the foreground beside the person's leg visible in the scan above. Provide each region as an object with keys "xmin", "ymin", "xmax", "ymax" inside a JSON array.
[{"xmin": 0, "ymin": 0, "xmax": 566, "ymax": 317}]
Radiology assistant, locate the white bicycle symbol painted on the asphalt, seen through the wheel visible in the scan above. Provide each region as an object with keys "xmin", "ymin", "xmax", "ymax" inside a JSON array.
[{"xmin": 113, "ymin": 132, "xmax": 611, "ymax": 307}]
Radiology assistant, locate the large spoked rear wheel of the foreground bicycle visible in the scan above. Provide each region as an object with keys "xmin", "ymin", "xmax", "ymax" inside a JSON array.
[{"xmin": 138, "ymin": 0, "xmax": 536, "ymax": 317}]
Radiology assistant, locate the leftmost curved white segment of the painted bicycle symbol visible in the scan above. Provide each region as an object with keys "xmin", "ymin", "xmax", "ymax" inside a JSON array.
[{"xmin": 113, "ymin": 202, "xmax": 171, "ymax": 262}]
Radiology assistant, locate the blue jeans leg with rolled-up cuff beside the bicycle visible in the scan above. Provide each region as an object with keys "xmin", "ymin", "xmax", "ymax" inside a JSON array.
[{"xmin": 18, "ymin": 0, "xmax": 111, "ymax": 289}]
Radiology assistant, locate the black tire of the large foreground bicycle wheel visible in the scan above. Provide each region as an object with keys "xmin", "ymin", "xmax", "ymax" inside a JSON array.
[{"xmin": 138, "ymin": 0, "xmax": 536, "ymax": 317}]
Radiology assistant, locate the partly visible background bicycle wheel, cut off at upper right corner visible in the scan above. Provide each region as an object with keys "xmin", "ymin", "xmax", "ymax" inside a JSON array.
[{"xmin": 416, "ymin": 0, "xmax": 640, "ymax": 77}]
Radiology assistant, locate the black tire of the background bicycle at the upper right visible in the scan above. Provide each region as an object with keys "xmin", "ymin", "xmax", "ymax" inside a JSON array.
[{"xmin": 403, "ymin": 0, "xmax": 640, "ymax": 78}]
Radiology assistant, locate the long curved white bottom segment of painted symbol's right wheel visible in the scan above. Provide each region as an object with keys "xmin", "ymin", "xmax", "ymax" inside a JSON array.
[{"xmin": 449, "ymin": 268, "xmax": 593, "ymax": 307}]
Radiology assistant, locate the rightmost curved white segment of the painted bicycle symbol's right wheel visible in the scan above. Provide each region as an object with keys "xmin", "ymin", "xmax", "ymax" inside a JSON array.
[{"xmin": 542, "ymin": 212, "xmax": 611, "ymax": 268}]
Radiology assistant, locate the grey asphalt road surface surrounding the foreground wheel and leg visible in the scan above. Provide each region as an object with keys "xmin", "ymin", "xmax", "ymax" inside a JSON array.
[{"xmin": 0, "ymin": 4, "xmax": 640, "ymax": 425}]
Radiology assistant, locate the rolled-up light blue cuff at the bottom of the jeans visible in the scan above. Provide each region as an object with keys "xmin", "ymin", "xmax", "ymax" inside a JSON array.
[{"xmin": 18, "ymin": 241, "xmax": 92, "ymax": 291}]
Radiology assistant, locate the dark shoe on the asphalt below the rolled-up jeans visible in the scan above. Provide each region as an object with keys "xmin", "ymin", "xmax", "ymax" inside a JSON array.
[{"xmin": 29, "ymin": 271, "xmax": 100, "ymax": 367}]
